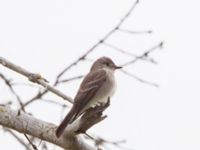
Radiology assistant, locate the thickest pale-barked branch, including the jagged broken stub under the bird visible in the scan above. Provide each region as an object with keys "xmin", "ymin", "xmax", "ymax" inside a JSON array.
[{"xmin": 0, "ymin": 100, "xmax": 110, "ymax": 150}]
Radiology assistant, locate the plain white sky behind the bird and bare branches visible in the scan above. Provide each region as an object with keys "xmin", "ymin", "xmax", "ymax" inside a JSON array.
[{"xmin": 0, "ymin": 0, "xmax": 200, "ymax": 150}]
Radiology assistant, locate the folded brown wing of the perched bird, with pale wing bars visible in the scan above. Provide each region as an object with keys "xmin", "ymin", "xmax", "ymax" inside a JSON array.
[{"xmin": 73, "ymin": 70, "xmax": 107, "ymax": 120}]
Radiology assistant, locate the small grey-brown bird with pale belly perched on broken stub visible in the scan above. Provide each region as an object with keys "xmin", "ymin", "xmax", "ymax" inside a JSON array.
[{"xmin": 56, "ymin": 57, "xmax": 122, "ymax": 137}]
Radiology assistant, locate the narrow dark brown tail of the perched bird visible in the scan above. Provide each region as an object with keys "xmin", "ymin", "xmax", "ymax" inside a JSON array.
[{"xmin": 56, "ymin": 108, "xmax": 76, "ymax": 138}]
